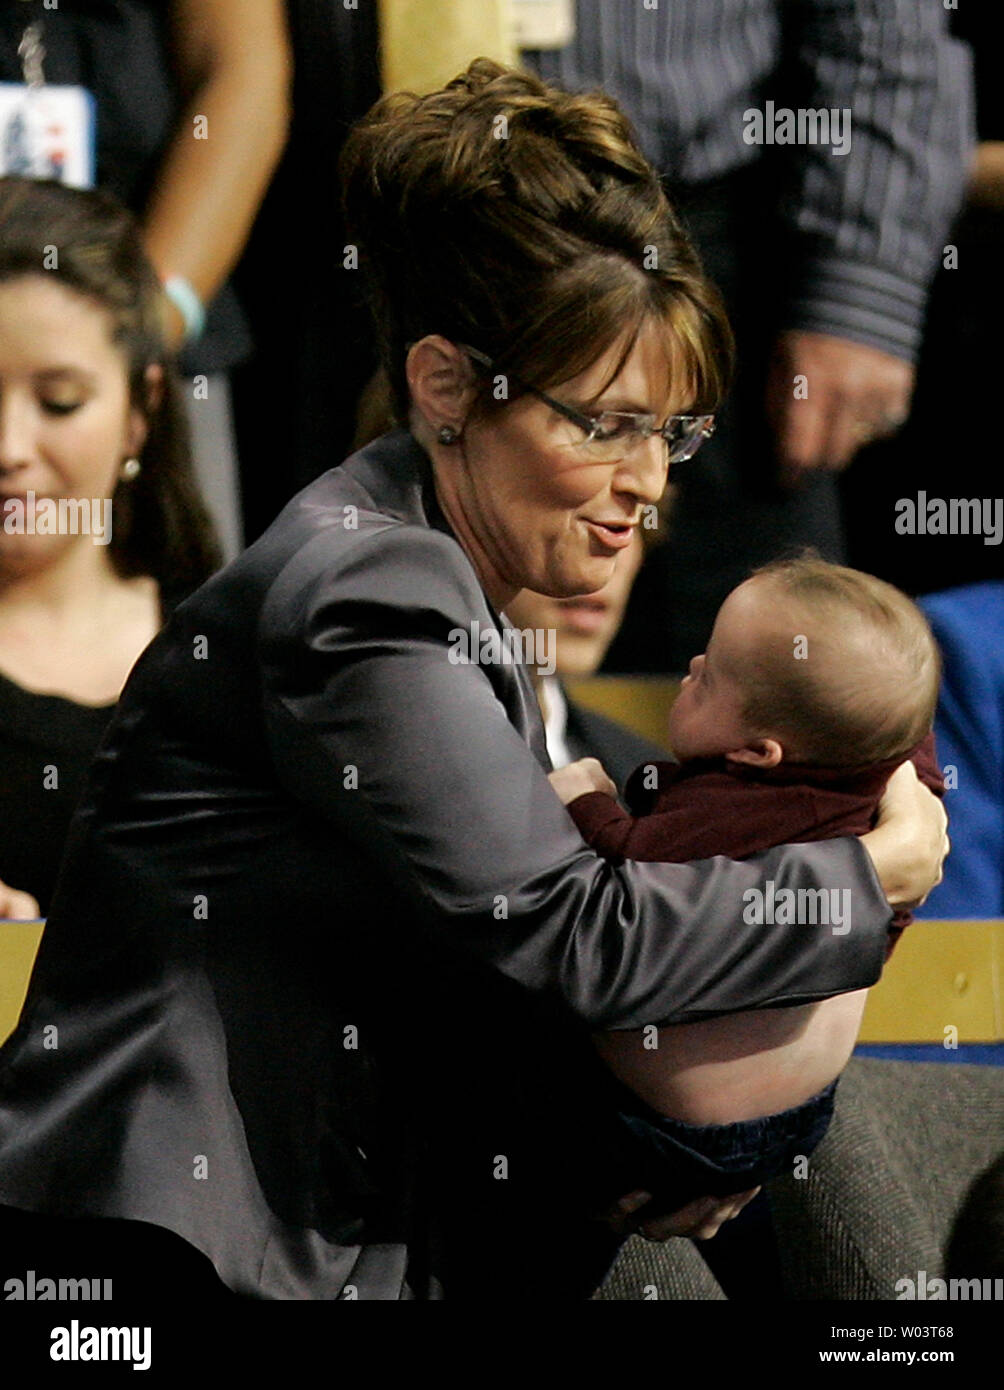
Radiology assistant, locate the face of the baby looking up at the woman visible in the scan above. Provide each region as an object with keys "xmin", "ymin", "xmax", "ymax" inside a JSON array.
[{"xmin": 669, "ymin": 580, "xmax": 769, "ymax": 762}]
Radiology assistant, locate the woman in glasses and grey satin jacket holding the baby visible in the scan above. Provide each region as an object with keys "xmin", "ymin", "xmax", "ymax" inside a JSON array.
[{"xmin": 0, "ymin": 60, "xmax": 946, "ymax": 1301}]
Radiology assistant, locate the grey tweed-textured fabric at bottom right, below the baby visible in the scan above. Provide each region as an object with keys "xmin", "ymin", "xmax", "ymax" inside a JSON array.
[{"xmin": 597, "ymin": 1058, "xmax": 1004, "ymax": 1300}]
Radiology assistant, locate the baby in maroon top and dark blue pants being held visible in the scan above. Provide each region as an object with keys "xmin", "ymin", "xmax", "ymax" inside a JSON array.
[{"xmin": 551, "ymin": 556, "xmax": 944, "ymax": 1218}]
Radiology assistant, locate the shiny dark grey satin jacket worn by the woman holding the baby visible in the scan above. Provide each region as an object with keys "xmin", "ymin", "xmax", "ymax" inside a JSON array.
[{"xmin": 0, "ymin": 431, "xmax": 890, "ymax": 1298}]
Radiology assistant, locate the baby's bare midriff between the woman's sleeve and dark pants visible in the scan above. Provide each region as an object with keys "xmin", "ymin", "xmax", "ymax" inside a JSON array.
[{"xmin": 594, "ymin": 990, "xmax": 868, "ymax": 1125}]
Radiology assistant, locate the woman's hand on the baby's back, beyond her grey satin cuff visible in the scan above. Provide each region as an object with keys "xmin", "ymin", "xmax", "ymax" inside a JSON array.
[{"xmin": 861, "ymin": 762, "xmax": 950, "ymax": 909}]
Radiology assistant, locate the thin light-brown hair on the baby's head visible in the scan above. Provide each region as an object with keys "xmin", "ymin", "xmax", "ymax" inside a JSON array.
[{"xmin": 744, "ymin": 550, "xmax": 941, "ymax": 766}]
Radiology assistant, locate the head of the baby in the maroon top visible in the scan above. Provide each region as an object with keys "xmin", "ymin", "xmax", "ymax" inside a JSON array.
[{"xmin": 669, "ymin": 556, "xmax": 941, "ymax": 767}]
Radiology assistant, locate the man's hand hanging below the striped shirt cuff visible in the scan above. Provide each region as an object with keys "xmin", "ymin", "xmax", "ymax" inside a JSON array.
[{"xmin": 766, "ymin": 331, "xmax": 915, "ymax": 487}]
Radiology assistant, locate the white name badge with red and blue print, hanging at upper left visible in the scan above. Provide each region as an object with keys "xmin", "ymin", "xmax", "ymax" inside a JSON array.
[{"xmin": 0, "ymin": 82, "xmax": 96, "ymax": 188}]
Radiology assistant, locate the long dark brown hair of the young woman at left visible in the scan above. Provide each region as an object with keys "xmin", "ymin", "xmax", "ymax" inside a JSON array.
[{"xmin": 0, "ymin": 178, "xmax": 221, "ymax": 599}]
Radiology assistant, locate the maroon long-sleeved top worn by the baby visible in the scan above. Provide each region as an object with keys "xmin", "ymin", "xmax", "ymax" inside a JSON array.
[{"xmin": 569, "ymin": 734, "xmax": 944, "ymax": 952}]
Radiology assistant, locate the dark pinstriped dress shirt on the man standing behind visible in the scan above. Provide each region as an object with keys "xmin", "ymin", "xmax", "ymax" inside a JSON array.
[{"xmin": 523, "ymin": 0, "xmax": 975, "ymax": 361}]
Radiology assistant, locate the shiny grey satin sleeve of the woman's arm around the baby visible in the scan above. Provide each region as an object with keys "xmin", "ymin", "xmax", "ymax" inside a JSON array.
[{"xmin": 259, "ymin": 525, "xmax": 891, "ymax": 1029}]
